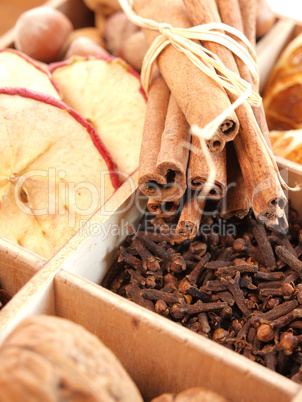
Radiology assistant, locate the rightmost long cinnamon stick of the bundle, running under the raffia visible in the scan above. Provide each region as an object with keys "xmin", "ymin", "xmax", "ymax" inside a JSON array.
[{"xmin": 184, "ymin": 0, "xmax": 286, "ymax": 220}]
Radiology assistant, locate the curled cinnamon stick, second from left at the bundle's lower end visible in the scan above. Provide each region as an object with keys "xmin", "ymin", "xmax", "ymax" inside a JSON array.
[{"xmin": 156, "ymin": 94, "xmax": 191, "ymax": 198}]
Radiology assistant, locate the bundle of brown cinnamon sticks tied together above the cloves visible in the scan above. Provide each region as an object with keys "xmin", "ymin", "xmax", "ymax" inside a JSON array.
[{"xmin": 133, "ymin": 0, "xmax": 286, "ymax": 238}]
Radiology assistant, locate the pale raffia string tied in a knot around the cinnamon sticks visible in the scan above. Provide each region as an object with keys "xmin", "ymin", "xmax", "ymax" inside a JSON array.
[{"xmin": 119, "ymin": 0, "xmax": 300, "ymax": 191}]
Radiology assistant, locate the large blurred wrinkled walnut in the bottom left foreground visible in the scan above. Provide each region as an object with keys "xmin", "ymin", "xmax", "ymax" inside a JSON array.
[{"xmin": 0, "ymin": 315, "xmax": 143, "ymax": 402}]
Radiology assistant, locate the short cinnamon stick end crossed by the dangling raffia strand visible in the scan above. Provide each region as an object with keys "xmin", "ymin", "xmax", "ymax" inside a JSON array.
[{"xmin": 187, "ymin": 143, "xmax": 227, "ymax": 200}]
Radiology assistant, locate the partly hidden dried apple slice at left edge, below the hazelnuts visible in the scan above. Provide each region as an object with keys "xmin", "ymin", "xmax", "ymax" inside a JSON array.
[{"xmin": 0, "ymin": 49, "xmax": 61, "ymax": 99}]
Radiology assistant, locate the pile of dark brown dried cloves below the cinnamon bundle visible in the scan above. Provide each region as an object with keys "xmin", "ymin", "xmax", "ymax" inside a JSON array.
[{"xmin": 102, "ymin": 210, "xmax": 302, "ymax": 383}]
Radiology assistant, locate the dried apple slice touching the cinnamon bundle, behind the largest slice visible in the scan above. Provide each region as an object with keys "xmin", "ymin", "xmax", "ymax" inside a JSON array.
[{"xmin": 50, "ymin": 57, "xmax": 146, "ymax": 175}]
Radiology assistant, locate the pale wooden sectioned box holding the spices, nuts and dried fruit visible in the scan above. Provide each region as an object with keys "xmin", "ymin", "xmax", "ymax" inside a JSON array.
[{"xmin": 0, "ymin": 0, "xmax": 302, "ymax": 402}]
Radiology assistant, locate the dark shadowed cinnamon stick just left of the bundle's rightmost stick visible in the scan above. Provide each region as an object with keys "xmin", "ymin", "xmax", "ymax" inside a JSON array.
[{"xmin": 220, "ymin": 143, "xmax": 251, "ymax": 219}]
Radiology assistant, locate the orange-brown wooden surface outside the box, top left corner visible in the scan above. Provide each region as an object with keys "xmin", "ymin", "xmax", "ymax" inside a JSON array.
[{"xmin": 0, "ymin": 0, "xmax": 45, "ymax": 35}]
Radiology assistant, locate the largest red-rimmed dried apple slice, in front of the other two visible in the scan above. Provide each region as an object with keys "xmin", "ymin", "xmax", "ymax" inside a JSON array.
[{"xmin": 0, "ymin": 87, "xmax": 119, "ymax": 258}]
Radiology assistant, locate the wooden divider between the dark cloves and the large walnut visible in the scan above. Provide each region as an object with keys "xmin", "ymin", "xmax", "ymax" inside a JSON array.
[{"xmin": 55, "ymin": 270, "xmax": 300, "ymax": 402}]
